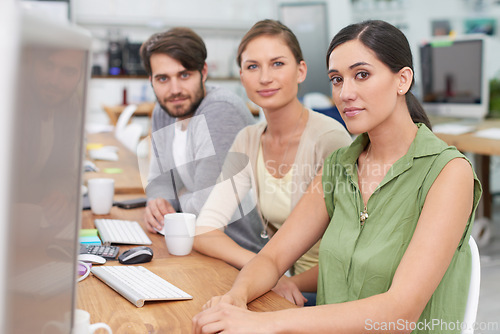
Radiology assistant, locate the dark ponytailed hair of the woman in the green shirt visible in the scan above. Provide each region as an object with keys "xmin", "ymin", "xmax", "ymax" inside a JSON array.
[{"xmin": 326, "ymin": 20, "xmax": 431, "ymax": 129}]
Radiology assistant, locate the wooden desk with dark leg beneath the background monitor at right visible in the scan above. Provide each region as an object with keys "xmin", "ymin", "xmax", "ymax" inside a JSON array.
[{"xmin": 436, "ymin": 119, "xmax": 500, "ymax": 219}]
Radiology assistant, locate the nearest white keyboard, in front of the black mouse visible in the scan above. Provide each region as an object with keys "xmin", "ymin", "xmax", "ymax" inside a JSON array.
[{"xmin": 91, "ymin": 266, "xmax": 193, "ymax": 307}]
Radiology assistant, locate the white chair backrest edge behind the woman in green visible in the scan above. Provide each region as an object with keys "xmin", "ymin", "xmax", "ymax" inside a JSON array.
[{"xmin": 462, "ymin": 236, "xmax": 481, "ymax": 334}]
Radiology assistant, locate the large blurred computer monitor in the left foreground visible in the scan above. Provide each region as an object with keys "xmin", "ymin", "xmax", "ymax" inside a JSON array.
[{"xmin": 0, "ymin": 0, "xmax": 91, "ymax": 334}]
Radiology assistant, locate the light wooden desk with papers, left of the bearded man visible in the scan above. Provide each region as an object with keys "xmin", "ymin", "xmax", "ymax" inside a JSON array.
[{"xmin": 83, "ymin": 132, "xmax": 144, "ymax": 194}]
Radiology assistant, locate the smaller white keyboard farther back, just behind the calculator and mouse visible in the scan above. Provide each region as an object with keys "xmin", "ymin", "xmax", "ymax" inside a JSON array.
[{"xmin": 94, "ymin": 219, "xmax": 152, "ymax": 245}]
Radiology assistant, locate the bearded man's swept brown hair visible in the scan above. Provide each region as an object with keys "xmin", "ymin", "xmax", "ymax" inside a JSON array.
[{"xmin": 140, "ymin": 27, "xmax": 207, "ymax": 75}]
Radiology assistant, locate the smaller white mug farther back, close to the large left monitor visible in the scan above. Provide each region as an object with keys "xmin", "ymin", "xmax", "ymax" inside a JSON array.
[{"xmin": 87, "ymin": 178, "xmax": 115, "ymax": 215}]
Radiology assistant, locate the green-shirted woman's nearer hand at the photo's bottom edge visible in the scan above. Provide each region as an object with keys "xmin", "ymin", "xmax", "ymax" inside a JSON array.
[{"xmin": 192, "ymin": 302, "xmax": 273, "ymax": 334}]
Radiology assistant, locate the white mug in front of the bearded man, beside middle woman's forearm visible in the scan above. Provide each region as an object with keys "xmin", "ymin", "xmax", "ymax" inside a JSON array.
[{"xmin": 163, "ymin": 212, "xmax": 196, "ymax": 256}]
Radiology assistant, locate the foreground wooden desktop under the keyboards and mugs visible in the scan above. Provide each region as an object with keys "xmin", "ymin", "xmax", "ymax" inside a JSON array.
[{"xmin": 77, "ymin": 207, "xmax": 296, "ymax": 334}]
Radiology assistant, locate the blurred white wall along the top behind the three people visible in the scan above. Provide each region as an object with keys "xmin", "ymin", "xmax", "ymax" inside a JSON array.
[{"xmin": 77, "ymin": 0, "xmax": 500, "ymax": 77}]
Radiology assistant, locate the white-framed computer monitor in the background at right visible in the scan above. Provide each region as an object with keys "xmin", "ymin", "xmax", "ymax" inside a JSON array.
[{"xmin": 420, "ymin": 35, "xmax": 489, "ymax": 119}]
